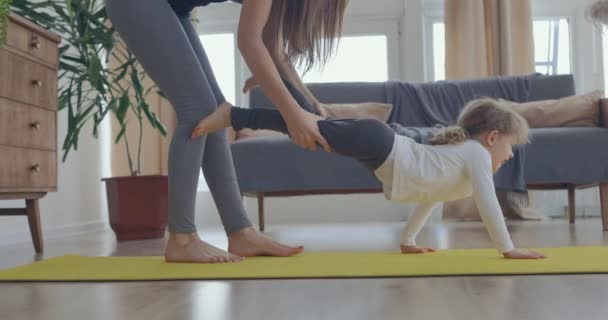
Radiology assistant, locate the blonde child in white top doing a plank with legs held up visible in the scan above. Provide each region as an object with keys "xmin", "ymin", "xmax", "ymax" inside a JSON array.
[{"xmin": 192, "ymin": 99, "xmax": 545, "ymax": 259}]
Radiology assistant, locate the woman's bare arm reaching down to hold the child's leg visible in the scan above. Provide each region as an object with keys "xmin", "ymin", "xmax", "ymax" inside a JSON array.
[{"xmin": 238, "ymin": 0, "xmax": 330, "ymax": 151}]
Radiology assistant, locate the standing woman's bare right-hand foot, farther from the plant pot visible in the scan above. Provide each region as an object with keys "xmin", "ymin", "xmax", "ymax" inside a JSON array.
[{"xmin": 228, "ymin": 227, "xmax": 304, "ymax": 257}]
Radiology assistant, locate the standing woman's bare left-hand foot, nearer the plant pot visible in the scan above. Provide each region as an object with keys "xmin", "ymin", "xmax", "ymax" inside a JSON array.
[{"xmin": 165, "ymin": 233, "xmax": 243, "ymax": 263}]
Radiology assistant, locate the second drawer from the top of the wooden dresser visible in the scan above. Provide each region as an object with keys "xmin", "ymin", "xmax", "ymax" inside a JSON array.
[{"xmin": 0, "ymin": 49, "xmax": 57, "ymax": 110}]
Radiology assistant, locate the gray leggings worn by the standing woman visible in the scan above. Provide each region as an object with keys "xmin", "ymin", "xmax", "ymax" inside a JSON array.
[{"xmin": 106, "ymin": 0, "xmax": 251, "ymax": 234}]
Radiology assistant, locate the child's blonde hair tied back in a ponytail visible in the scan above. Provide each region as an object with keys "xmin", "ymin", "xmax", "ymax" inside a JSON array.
[{"xmin": 428, "ymin": 98, "xmax": 529, "ymax": 145}]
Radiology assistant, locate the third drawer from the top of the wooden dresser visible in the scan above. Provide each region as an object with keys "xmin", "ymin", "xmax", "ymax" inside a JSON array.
[{"xmin": 0, "ymin": 98, "xmax": 57, "ymax": 151}]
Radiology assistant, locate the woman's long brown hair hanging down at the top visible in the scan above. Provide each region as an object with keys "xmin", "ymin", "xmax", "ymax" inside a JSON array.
[{"xmin": 267, "ymin": 0, "xmax": 348, "ymax": 73}]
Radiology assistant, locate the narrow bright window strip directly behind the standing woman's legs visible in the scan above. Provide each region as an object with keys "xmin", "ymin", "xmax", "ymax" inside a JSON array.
[{"xmin": 198, "ymin": 33, "xmax": 236, "ymax": 191}]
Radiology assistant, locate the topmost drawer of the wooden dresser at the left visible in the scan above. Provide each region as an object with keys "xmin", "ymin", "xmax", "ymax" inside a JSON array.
[{"xmin": 6, "ymin": 16, "xmax": 59, "ymax": 69}]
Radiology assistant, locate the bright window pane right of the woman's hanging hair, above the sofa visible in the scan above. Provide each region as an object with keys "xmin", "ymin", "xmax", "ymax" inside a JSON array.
[{"xmin": 299, "ymin": 35, "xmax": 389, "ymax": 83}]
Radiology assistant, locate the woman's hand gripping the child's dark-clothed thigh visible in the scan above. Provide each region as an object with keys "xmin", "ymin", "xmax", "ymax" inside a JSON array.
[{"xmin": 284, "ymin": 109, "xmax": 331, "ymax": 152}]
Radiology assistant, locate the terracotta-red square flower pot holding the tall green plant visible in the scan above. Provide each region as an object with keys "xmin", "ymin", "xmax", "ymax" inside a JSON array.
[{"xmin": 102, "ymin": 175, "xmax": 169, "ymax": 241}]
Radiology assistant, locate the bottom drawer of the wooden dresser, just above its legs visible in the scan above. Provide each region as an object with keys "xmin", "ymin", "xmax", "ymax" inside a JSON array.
[{"xmin": 0, "ymin": 146, "xmax": 57, "ymax": 188}]
